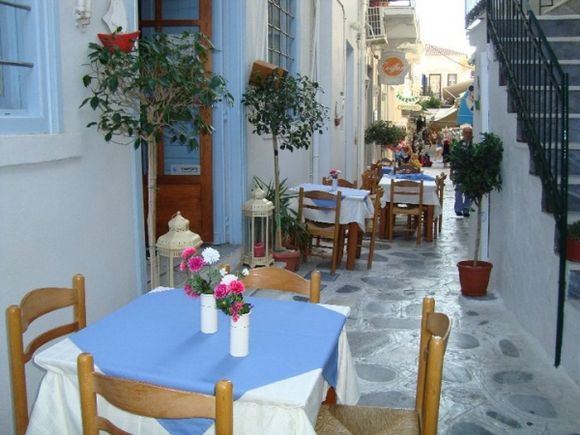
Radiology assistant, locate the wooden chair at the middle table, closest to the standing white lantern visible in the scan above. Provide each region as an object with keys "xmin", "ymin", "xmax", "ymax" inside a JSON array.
[{"xmin": 298, "ymin": 188, "xmax": 344, "ymax": 275}]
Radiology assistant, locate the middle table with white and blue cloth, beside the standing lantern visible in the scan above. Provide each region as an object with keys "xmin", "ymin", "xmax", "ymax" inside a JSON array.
[{"xmin": 290, "ymin": 183, "xmax": 374, "ymax": 270}]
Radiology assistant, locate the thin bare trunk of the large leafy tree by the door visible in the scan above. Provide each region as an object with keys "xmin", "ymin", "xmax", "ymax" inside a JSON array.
[{"xmin": 147, "ymin": 137, "xmax": 159, "ymax": 289}]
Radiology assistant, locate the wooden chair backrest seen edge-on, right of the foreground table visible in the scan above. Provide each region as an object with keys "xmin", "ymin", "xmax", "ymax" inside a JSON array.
[{"xmin": 415, "ymin": 297, "xmax": 451, "ymax": 435}]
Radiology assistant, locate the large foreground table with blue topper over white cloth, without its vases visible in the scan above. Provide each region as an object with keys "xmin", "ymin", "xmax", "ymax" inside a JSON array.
[{"xmin": 27, "ymin": 288, "xmax": 359, "ymax": 435}]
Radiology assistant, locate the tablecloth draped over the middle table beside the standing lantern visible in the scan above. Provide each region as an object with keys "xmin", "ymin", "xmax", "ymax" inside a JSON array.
[{"xmin": 290, "ymin": 183, "xmax": 375, "ymax": 231}]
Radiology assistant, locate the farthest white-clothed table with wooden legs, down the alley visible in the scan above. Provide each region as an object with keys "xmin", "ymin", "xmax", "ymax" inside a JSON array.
[{"xmin": 379, "ymin": 173, "xmax": 441, "ymax": 242}]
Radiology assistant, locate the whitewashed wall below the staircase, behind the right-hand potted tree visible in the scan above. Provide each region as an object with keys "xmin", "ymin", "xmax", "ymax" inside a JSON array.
[{"xmin": 470, "ymin": 19, "xmax": 580, "ymax": 384}]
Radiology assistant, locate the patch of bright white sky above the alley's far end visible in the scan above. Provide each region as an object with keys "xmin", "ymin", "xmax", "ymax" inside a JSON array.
[{"xmin": 415, "ymin": 0, "xmax": 473, "ymax": 53}]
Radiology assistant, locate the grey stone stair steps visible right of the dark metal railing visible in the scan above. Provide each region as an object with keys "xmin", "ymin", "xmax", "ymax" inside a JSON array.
[{"xmin": 538, "ymin": 0, "xmax": 580, "ymax": 301}]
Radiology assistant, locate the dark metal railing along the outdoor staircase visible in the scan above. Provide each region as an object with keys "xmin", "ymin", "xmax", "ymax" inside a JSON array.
[{"xmin": 485, "ymin": 0, "xmax": 568, "ymax": 366}]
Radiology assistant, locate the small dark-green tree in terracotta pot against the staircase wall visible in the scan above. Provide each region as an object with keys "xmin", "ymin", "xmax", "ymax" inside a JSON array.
[{"xmin": 449, "ymin": 133, "xmax": 503, "ymax": 296}]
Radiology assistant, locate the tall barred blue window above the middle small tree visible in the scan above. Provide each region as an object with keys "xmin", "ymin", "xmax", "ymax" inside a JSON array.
[{"xmin": 268, "ymin": 0, "xmax": 294, "ymax": 71}]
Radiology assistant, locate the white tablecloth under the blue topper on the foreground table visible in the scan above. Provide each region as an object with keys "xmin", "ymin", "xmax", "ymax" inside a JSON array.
[{"xmin": 27, "ymin": 302, "xmax": 359, "ymax": 435}]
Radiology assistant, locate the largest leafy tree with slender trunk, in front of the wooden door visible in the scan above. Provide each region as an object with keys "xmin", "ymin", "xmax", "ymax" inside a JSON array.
[{"xmin": 81, "ymin": 33, "xmax": 232, "ymax": 287}]
